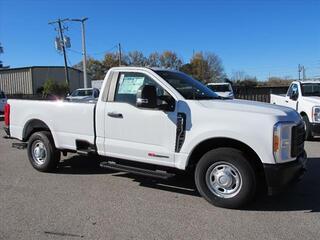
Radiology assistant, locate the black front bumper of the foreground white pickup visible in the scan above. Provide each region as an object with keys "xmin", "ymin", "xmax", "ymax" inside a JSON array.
[{"xmin": 263, "ymin": 152, "xmax": 307, "ymax": 195}]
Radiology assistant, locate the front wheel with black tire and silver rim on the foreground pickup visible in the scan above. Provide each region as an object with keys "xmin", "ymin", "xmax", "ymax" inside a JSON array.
[{"xmin": 195, "ymin": 148, "xmax": 257, "ymax": 208}]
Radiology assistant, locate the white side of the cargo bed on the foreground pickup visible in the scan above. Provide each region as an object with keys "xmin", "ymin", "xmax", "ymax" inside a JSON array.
[{"xmin": 8, "ymin": 99, "xmax": 95, "ymax": 150}]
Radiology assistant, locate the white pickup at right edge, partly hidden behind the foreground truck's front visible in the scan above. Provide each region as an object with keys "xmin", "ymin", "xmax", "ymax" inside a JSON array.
[{"xmin": 270, "ymin": 81, "xmax": 320, "ymax": 140}]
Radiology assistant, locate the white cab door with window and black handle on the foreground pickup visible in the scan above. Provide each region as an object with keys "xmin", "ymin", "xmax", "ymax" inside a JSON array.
[{"xmin": 104, "ymin": 72, "xmax": 177, "ymax": 166}]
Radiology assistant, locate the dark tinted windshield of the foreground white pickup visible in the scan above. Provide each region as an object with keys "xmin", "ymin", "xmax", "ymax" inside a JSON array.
[{"xmin": 155, "ymin": 70, "xmax": 221, "ymax": 100}]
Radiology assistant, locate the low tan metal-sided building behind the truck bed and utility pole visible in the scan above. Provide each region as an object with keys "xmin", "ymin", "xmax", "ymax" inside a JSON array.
[{"xmin": 0, "ymin": 66, "xmax": 83, "ymax": 96}]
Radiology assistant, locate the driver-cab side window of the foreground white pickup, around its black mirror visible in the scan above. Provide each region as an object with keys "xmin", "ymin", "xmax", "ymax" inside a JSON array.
[{"xmin": 114, "ymin": 72, "xmax": 170, "ymax": 106}]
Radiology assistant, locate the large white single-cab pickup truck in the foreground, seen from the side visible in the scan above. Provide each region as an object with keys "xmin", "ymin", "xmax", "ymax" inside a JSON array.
[{"xmin": 5, "ymin": 67, "xmax": 306, "ymax": 208}]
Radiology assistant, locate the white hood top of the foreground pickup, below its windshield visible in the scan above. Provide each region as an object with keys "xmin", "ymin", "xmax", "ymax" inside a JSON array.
[{"xmin": 199, "ymin": 99, "xmax": 300, "ymax": 119}]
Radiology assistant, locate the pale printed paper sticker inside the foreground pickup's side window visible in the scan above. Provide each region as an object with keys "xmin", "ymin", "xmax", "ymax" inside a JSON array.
[{"xmin": 118, "ymin": 74, "xmax": 144, "ymax": 94}]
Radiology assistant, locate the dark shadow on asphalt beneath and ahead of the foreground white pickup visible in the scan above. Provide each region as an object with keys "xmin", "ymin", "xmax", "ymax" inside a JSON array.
[{"xmin": 56, "ymin": 156, "xmax": 320, "ymax": 212}]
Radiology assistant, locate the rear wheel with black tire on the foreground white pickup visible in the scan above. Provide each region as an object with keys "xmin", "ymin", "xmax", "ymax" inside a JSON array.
[{"xmin": 28, "ymin": 131, "xmax": 60, "ymax": 172}]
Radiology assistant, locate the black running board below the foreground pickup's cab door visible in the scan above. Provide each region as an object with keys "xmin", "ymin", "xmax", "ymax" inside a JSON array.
[{"xmin": 100, "ymin": 161, "xmax": 175, "ymax": 179}]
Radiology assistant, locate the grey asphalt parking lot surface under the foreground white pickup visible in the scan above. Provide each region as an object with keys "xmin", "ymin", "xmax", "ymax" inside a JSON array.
[{"xmin": 0, "ymin": 119, "xmax": 320, "ymax": 239}]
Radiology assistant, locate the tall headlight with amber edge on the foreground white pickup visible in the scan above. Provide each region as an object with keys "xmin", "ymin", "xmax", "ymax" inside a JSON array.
[{"xmin": 273, "ymin": 122, "xmax": 296, "ymax": 163}]
